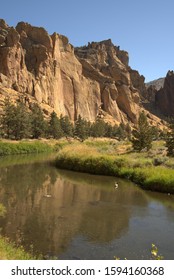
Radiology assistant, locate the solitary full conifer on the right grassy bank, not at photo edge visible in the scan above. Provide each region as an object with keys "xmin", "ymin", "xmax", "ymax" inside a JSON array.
[{"xmin": 131, "ymin": 112, "xmax": 153, "ymax": 152}]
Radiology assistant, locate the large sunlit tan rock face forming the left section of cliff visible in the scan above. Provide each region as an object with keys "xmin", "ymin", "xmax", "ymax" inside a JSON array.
[{"xmin": 0, "ymin": 21, "xmax": 101, "ymax": 121}]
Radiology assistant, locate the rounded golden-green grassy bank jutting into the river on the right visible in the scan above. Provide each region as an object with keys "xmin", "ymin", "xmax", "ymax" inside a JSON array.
[{"xmin": 55, "ymin": 140, "xmax": 174, "ymax": 194}]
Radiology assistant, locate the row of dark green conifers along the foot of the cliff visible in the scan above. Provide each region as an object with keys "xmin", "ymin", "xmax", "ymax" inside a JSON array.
[{"xmin": 0, "ymin": 100, "xmax": 130, "ymax": 141}]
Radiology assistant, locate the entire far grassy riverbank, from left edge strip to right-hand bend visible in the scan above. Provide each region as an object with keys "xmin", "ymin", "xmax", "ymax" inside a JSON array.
[{"xmin": 0, "ymin": 139, "xmax": 174, "ymax": 194}]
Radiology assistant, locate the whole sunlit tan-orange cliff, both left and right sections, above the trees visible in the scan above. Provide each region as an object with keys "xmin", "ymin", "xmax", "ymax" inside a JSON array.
[{"xmin": 0, "ymin": 20, "xmax": 164, "ymax": 128}]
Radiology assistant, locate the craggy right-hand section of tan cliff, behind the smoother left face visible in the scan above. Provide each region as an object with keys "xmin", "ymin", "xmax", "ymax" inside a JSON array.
[{"xmin": 75, "ymin": 40, "xmax": 145, "ymax": 123}]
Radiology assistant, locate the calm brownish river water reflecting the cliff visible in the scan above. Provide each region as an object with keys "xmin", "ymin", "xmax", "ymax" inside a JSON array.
[{"xmin": 0, "ymin": 155, "xmax": 174, "ymax": 260}]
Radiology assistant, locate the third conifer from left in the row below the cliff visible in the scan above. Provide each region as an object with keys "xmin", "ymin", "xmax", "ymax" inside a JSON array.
[{"xmin": 31, "ymin": 103, "xmax": 47, "ymax": 139}]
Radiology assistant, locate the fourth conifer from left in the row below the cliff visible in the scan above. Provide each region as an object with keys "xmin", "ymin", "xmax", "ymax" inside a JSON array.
[{"xmin": 49, "ymin": 112, "xmax": 63, "ymax": 139}]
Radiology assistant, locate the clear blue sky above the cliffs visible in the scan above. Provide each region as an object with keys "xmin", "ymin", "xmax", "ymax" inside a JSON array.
[{"xmin": 0, "ymin": 0, "xmax": 174, "ymax": 81}]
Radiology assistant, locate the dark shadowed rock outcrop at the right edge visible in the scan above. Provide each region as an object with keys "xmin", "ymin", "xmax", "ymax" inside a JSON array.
[{"xmin": 155, "ymin": 71, "xmax": 174, "ymax": 116}]
